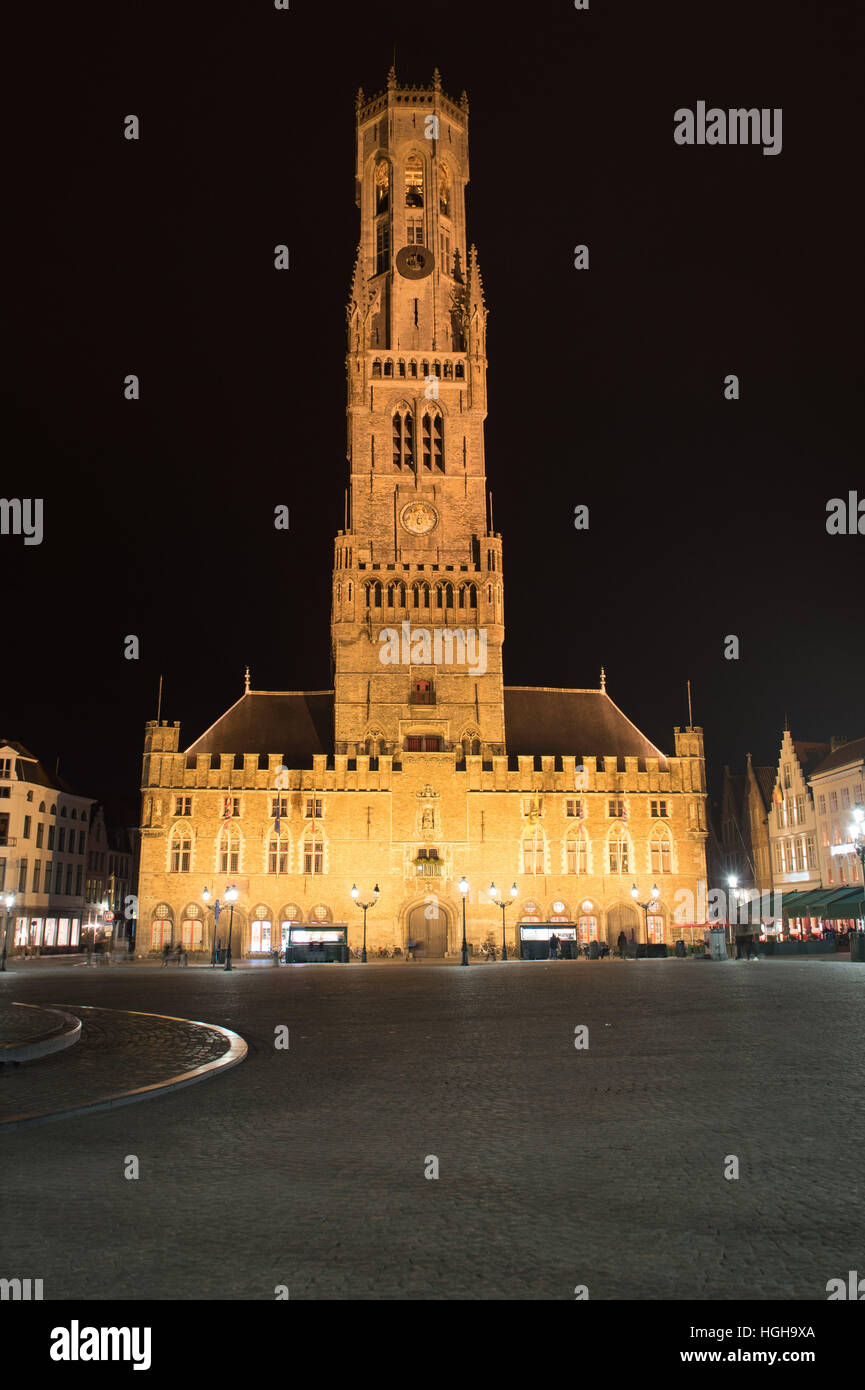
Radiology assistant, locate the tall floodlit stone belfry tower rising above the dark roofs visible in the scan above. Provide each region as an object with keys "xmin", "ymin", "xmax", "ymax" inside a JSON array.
[{"xmin": 331, "ymin": 68, "xmax": 505, "ymax": 756}]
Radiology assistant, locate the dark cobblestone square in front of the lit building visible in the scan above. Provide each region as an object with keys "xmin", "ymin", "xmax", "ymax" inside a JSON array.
[{"xmin": 0, "ymin": 959, "xmax": 865, "ymax": 1301}]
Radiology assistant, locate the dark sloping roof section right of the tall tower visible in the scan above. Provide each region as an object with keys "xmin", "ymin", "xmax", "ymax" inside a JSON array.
[{"xmin": 505, "ymin": 685, "xmax": 666, "ymax": 767}]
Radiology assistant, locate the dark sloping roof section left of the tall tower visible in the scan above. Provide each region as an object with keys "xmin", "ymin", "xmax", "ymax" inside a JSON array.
[{"xmin": 186, "ymin": 691, "xmax": 334, "ymax": 767}]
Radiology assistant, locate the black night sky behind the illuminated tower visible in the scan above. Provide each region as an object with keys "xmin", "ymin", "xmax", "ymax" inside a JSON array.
[{"xmin": 0, "ymin": 0, "xmax": 865, "ymax": 823}]
